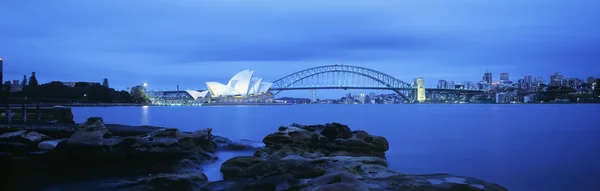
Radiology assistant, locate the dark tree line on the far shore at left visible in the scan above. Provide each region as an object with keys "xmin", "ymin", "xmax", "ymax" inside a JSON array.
[{"xmin": 0, "ymin": 72, "xmax": 149, "ymax": 103}]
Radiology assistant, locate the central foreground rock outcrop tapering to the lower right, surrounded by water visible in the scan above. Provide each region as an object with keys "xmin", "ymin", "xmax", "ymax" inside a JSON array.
[{"xmin": 213, "ymin": 123, "xmax": 507, "ymax": 191}]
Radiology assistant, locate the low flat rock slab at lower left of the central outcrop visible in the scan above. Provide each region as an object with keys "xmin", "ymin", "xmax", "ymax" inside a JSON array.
[{"xmin": 221, "ymin": 157, "xmax": 325, "ymax": 180}]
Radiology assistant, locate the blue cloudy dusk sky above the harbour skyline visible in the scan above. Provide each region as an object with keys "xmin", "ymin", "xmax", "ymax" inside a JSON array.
[{"xmin": 0, "ymin": 0, "xmax": 600, "ymax": 97}]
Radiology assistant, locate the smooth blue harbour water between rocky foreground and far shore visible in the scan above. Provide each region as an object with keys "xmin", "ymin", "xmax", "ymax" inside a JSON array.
[{"xmin": 73, "ymin": 105, "xmax": 600, "ymax": 191}]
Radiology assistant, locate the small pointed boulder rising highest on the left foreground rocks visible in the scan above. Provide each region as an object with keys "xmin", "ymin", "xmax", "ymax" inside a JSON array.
[{"xmin": 67, "ymin": 117, "xmax": 112, "ymax": 144}]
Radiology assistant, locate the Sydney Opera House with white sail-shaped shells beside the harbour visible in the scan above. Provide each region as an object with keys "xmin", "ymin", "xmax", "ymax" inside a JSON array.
[{"xmin": 186, "ymin": 70, "xmax": 273, "ymax": 100}]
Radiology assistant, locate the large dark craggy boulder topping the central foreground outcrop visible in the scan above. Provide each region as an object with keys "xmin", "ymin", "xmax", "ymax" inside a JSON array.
[{"xmin": 255, "ymin": 123, "xmax": 389, "ymax": 159}]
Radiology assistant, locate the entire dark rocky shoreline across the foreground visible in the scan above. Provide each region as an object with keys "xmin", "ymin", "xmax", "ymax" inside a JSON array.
[{"xmin": 0, "ymin": 117, "xmax": 507, "ymax": 191}]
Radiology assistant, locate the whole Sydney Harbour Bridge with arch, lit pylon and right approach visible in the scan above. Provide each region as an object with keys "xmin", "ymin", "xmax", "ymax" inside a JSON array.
[{"xmin": 270, "ymin": 64, "xmax": 484, "ymax": 102}]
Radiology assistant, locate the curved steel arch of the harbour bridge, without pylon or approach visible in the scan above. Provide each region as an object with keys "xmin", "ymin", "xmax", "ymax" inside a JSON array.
[{"xmin": 271, "ymin": 65, "xmax": 413, "ymax": 100}]
